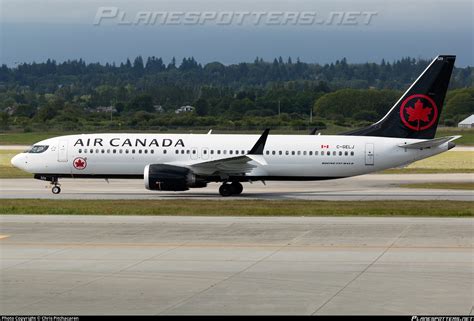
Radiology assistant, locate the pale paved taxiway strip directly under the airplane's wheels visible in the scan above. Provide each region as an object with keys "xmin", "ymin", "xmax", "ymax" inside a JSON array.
[{"xmin": 0, "ymin": 174, "xmax": 474, "ymax": 201}]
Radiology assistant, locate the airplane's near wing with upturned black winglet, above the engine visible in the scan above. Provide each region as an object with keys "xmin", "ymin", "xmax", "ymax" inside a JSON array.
[{"xmin": 166, "ymin": 129, "xmax": 270, "ymax": 176}]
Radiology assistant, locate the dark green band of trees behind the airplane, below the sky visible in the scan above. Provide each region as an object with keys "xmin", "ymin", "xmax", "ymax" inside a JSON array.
[{"xmin": 0, "ymin": 57, "xmax": 474, "ymax": 130}]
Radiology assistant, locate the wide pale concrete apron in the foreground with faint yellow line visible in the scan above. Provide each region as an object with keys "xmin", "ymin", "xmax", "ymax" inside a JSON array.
[{"xmin": 0, "ymin": 215, "xmax": 474, "ymax": 315}]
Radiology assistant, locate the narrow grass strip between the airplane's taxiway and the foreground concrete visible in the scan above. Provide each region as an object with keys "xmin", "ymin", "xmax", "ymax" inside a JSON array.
[{"xmin": 0, "ymin": 199, "xmax": 474, "ymax": 217}]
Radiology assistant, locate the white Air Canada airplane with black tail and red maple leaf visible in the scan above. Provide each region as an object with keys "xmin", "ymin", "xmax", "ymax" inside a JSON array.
[{"xmin": 11, "ymin": 55, "xmax": 460, "ymax": 196}]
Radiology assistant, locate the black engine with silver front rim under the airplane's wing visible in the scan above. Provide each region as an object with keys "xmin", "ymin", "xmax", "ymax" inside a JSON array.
[{"xmin": 143, "ymin": 164, "xmax": 207, "ymax": 191}]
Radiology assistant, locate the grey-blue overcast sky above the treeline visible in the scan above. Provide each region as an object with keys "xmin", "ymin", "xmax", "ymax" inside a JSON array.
[{"xmin": 0, "ymin": 0, "xmax": 474, "ymax": 66}]
